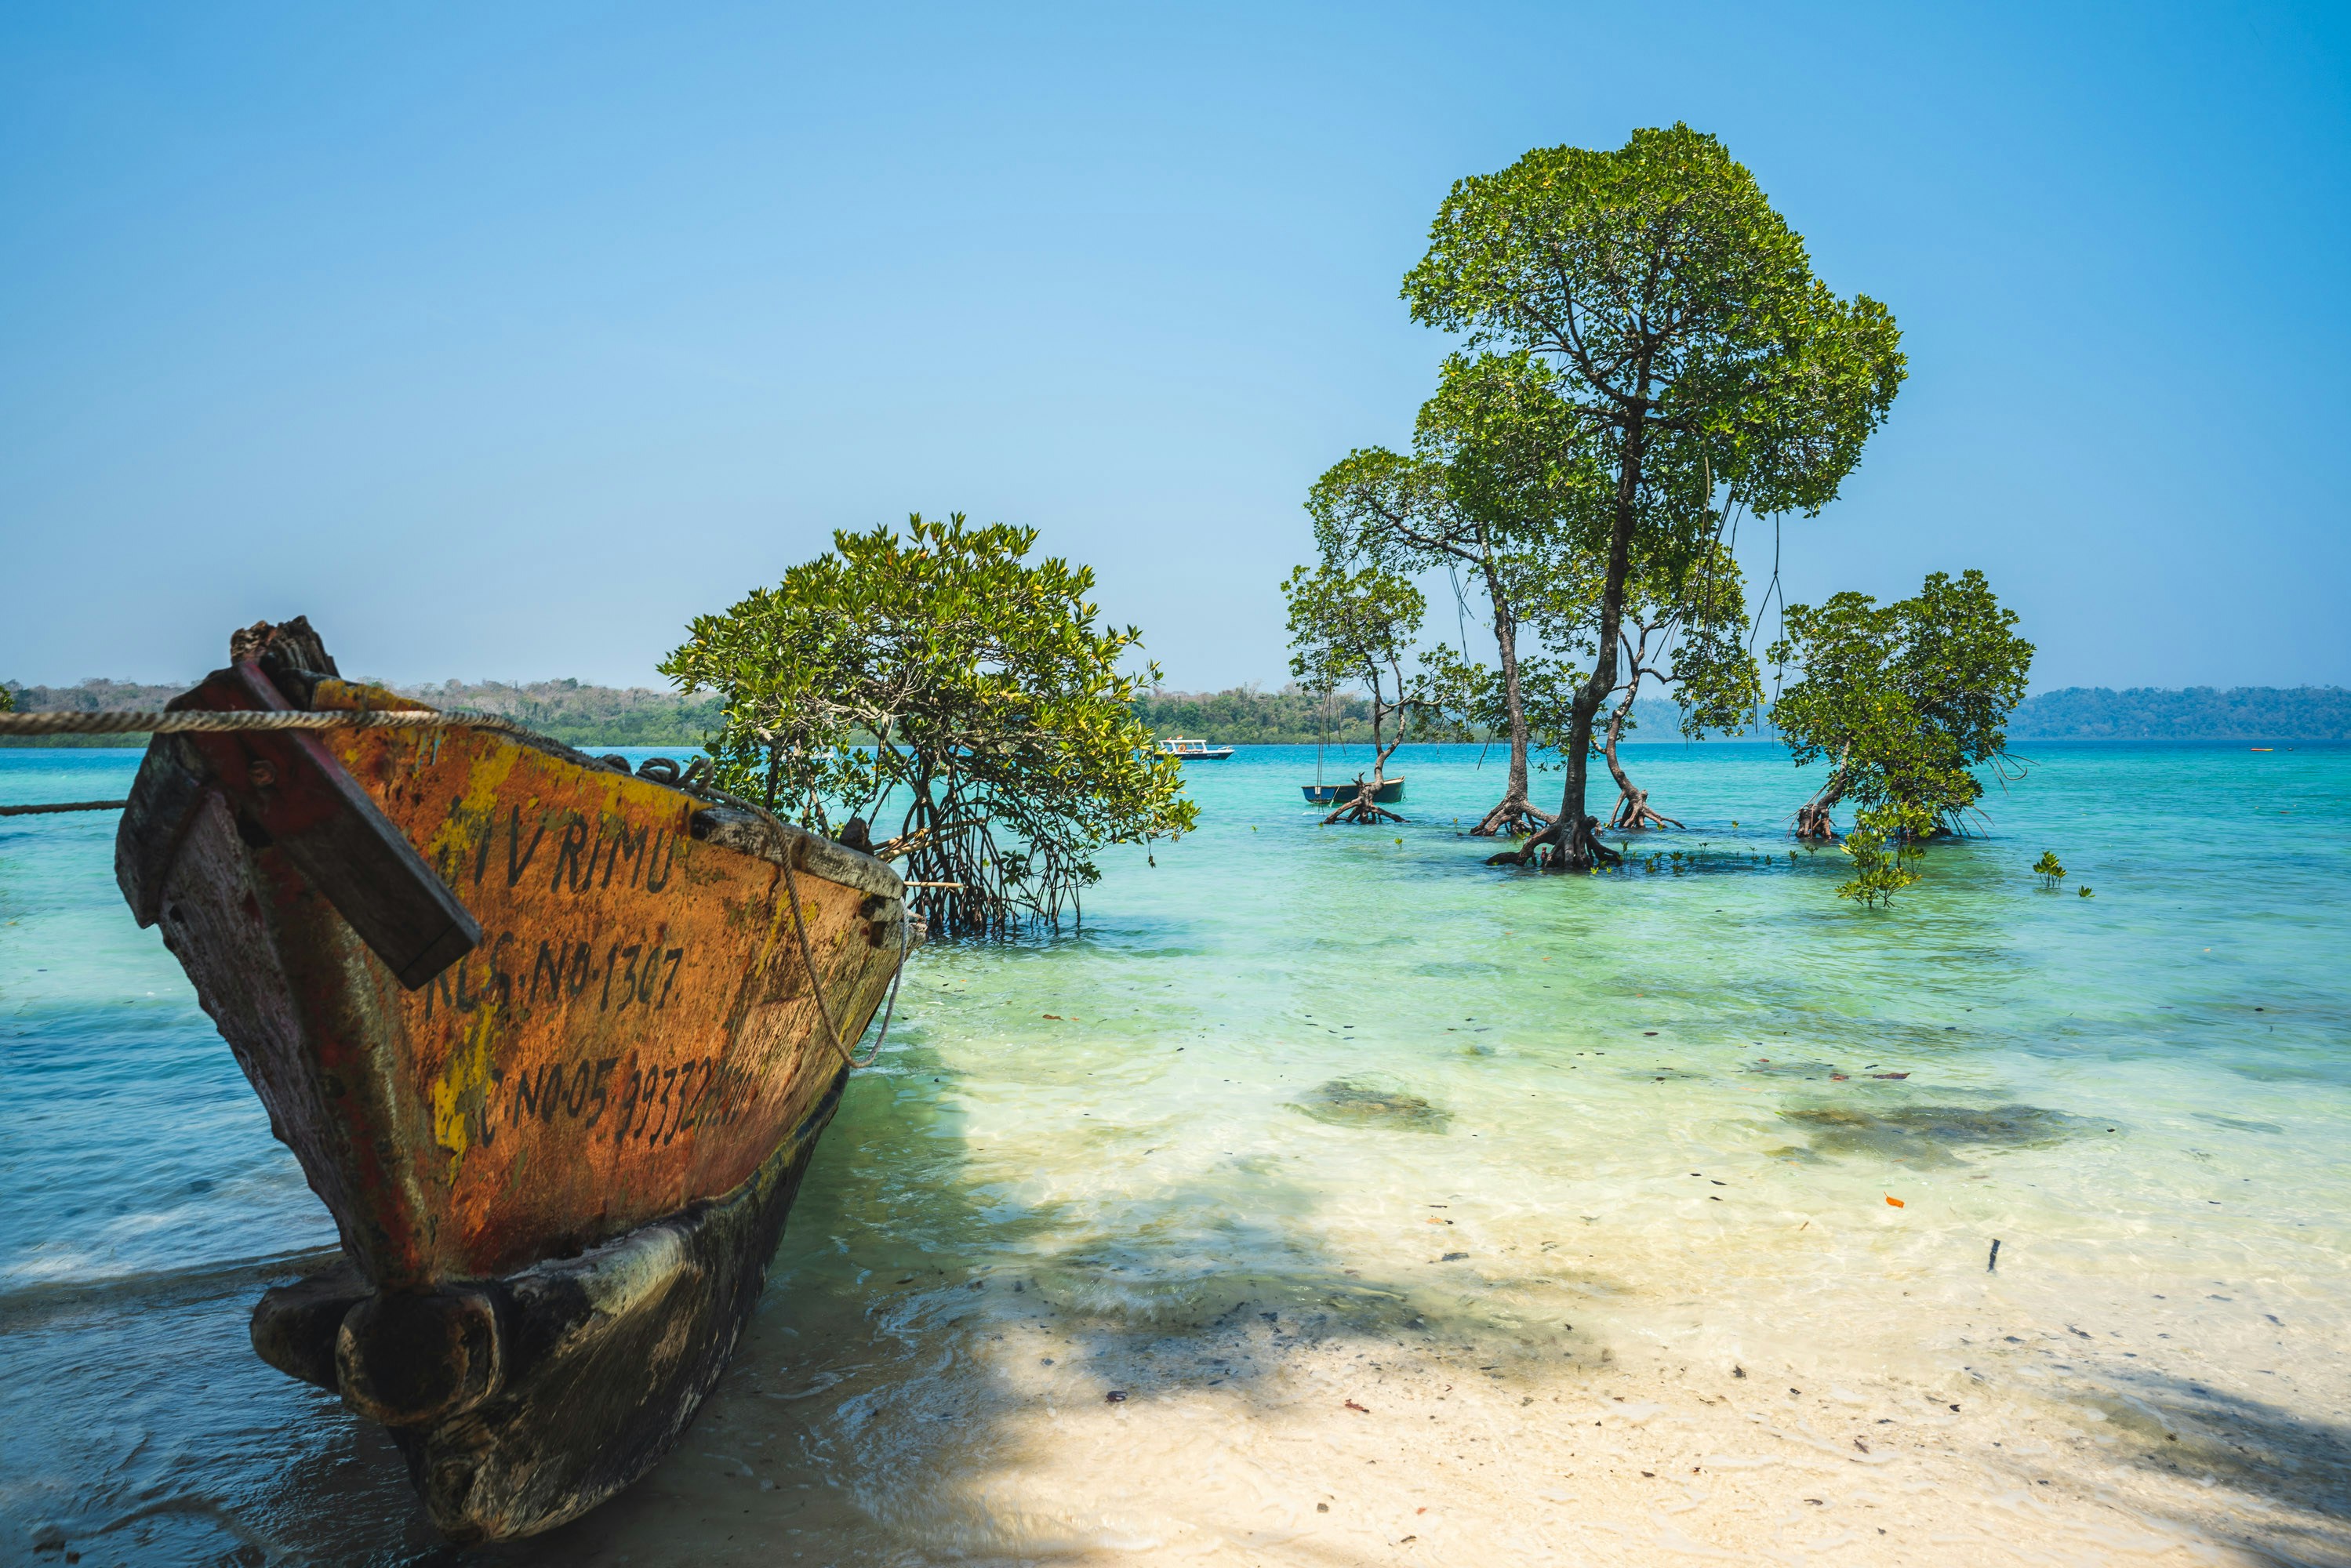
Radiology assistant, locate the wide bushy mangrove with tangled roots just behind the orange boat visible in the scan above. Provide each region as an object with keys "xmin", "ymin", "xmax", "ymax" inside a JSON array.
[{"xmin": 660, "ymin": 513, "xmax": 1197, "ymax": 935}]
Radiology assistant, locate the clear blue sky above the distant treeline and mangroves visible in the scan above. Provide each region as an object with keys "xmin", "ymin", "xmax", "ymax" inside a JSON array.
[{"xmin": 0, "ymin": 0, "xmax": 2351, "ymax": 689}]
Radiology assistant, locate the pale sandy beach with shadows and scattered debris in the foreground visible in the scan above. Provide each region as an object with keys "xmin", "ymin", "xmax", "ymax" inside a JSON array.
[{"xmin": 532, "ymin": 1194, "xmax": 2351, "ymax": 1566}]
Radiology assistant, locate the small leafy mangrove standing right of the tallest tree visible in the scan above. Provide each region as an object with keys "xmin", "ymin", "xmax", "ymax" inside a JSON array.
[{"xmin": 1770, "ymin": 572, "xmax": 2033, "ymax": 832}]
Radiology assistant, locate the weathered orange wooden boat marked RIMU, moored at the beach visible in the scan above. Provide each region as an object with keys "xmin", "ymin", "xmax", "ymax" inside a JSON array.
[{"xmin": 115, "ymin": 621, "xmax": 907, "ymax": 1542}]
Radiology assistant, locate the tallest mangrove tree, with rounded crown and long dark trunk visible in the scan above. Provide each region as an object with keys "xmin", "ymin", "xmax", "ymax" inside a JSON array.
[{"xmin": 1404, "ymin": 125, "xmax": 1904, "ymax": 867}]
